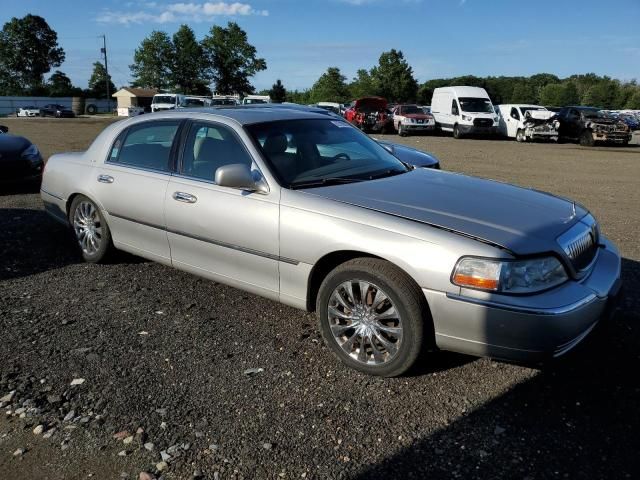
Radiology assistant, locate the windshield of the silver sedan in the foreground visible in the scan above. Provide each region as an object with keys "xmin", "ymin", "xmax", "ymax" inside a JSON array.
[{"xmin": 246, "ymin": 119, "xmax": 408, "ymax": 188}]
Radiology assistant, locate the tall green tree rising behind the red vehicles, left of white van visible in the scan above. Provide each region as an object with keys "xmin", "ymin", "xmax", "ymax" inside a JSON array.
[{"xmin": 371, "ymin": 49, "xmax": 418, "ymax": 102}]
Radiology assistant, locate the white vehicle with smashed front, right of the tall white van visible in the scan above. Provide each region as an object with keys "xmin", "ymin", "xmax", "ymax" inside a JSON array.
[{"xmin": 496, "ymin": 104, "xmax": 560, "ymax": 142}]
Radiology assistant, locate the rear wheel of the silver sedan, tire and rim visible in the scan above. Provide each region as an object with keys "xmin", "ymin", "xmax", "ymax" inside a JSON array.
[{"xmin": 69, "ymin": 195, "xmax": 114, "ymax": 263}]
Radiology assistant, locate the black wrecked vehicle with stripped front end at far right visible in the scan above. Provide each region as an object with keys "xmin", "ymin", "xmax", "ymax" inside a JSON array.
[{"xmin": 558, "ymin": 107, "xmax": 631, "ymax": 147}]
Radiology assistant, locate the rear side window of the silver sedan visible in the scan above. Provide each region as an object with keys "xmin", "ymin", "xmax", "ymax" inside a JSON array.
[{"xmin": 109, "ymin": 122, "xmax": 179, "ymax": 172}]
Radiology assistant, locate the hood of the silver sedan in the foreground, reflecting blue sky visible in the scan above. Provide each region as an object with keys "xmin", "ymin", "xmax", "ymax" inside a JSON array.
[{"xmin": 305, "ymin": 169, "xmax": 588, "ymax": 255}]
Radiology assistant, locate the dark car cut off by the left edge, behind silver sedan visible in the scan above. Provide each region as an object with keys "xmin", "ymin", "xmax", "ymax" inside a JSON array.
[{"xmin": 0, "ymin": 126, "xmax": 44, "ymax": 184}]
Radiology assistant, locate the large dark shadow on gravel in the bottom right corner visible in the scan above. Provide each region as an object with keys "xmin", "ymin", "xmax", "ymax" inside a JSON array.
[{"xmin": 351, "ymin": 259, "xmax": 640, "ymax": 480}]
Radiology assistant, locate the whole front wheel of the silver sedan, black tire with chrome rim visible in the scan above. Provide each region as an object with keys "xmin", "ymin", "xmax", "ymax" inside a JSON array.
[{"xmin": 316, "ymin": 258, "xmax": 433, "ymax": 377}]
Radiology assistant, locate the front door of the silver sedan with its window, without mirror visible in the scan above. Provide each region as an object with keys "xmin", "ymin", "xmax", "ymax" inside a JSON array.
[{"xmin": 165, "ymin": 121, "xmax": 279, "ymax": 298}]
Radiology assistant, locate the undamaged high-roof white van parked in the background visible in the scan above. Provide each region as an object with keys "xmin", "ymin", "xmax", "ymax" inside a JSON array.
[{"xmin": 431, "ymin": 87, "xmax": 498, "ymax": 138}]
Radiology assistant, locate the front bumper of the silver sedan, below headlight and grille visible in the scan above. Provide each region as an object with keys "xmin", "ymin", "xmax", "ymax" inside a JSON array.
[{"xmin": 423, "ymin": 237, "xmax": 621, "ymax": 363}]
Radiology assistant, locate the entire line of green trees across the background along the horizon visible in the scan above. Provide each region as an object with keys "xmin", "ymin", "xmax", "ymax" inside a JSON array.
[{"xmin": 0, "ymin": 14, "xmax": 640, "ymax": 109}]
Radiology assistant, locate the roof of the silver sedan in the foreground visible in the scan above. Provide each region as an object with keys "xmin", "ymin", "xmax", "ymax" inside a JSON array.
[{"xmin": 144, "ymin": 103, "xmax": 337, "ymax": 125}]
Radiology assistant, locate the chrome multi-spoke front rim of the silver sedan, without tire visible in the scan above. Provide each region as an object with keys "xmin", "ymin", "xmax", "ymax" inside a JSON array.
[{"xmin": 328, "ymin": 280, "xmax": 402, "ymax": 365}]
